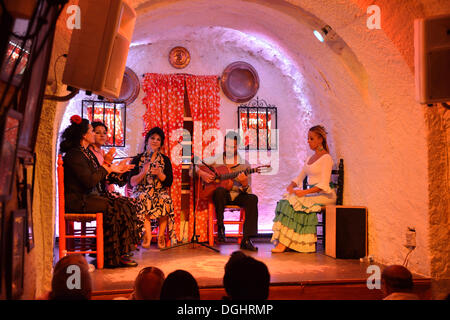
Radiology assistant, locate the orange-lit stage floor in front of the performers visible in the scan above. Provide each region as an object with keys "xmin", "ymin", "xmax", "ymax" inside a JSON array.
[{"xmin": 83, "ymin": 239, "xmax": 394, "ymax": 291}]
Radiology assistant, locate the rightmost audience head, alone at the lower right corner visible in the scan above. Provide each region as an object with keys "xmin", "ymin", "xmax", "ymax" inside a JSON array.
[{"xmin": 381, "ymin": 265, "xmax": 420, "ymax": 300}]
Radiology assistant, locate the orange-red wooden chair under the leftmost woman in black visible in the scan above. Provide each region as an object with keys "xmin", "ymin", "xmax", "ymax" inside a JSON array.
[{"xmin": 57, "ymin": 155, "xmax": 104, "ymax": 269}]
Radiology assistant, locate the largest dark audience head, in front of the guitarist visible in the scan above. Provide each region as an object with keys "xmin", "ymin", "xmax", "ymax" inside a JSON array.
[{"xmin": 223, "ymin": 251, "xmax": 270, "ymax": 300}]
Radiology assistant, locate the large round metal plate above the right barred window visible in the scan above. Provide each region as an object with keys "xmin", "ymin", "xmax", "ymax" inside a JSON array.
[{"xmin": 220, "ymin": 61, "xmax": 259, "ymax": 103}]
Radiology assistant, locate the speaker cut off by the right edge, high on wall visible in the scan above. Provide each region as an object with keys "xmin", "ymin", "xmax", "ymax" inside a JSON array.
[{"xmin": 414, "ymin": 15, "xmax": 450, "ymax": 104}]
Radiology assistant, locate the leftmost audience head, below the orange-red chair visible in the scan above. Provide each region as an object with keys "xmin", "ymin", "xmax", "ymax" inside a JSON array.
[{"xmin": 48, "ymin": 254, "xmax": 92, "ymax": 300}]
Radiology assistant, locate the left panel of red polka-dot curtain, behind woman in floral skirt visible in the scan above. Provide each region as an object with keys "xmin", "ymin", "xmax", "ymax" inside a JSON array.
[{"xmin": 142, "ymin": 73, "xmax": 184, "ymax": 239}]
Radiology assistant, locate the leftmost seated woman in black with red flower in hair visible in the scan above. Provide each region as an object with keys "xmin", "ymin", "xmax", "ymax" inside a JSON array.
[{"xmin": 60, "ymin": 116, "xmax": 142, "ymax": 267}]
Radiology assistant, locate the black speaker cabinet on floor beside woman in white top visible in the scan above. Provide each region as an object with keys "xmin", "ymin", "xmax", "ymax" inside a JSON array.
[{"xmin": 325, "ymin": 206, "xmax": 367, "ymax": 259}]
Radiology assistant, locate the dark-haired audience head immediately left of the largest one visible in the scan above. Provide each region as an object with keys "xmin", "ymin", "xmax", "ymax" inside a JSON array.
[{"xmin": 160, "ymin": 270, "xmax": 200, "ymax": 300}]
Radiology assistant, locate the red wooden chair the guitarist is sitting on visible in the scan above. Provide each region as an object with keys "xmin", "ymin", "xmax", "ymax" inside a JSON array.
[{"xmin": 208, "ymin": 200, "xmax": 245, "ymax": 246}]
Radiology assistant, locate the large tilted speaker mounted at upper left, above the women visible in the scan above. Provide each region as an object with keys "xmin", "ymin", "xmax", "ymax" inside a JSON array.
[{"xmin": 63, "ymin": 0, "xmax": 136, "ymax": 99}]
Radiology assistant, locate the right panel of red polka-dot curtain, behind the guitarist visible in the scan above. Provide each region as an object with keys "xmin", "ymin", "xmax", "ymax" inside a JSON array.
[{"xmin": 186, "ymin": 76, "xmax": 220, "ymax": 242}]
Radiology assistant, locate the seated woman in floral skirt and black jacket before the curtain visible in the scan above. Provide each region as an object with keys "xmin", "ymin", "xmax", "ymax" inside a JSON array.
[{"xmin": 129, "ymin": 127, "xmax": 176, "ymax": 248}]
